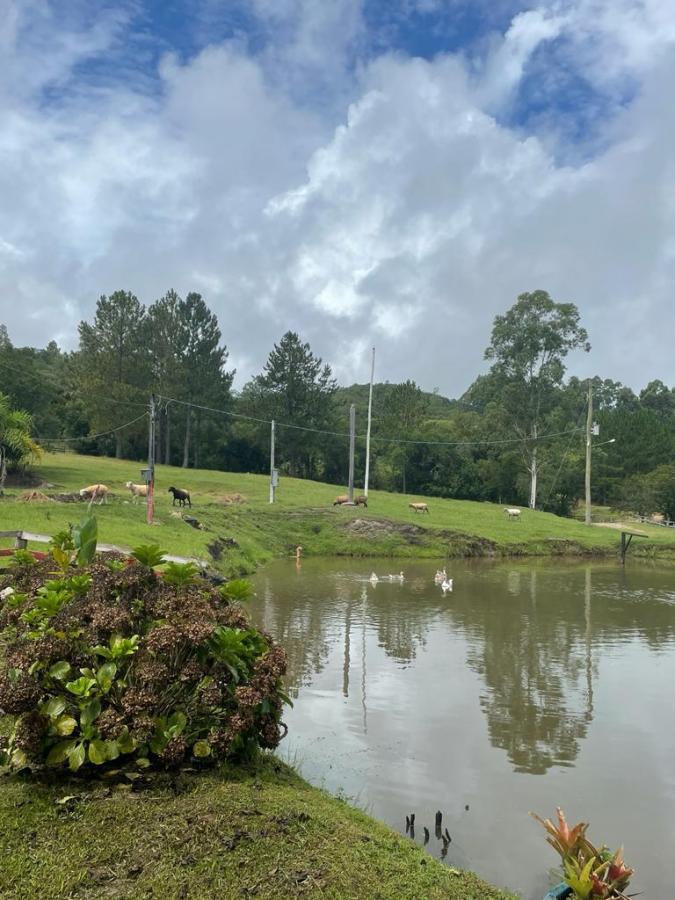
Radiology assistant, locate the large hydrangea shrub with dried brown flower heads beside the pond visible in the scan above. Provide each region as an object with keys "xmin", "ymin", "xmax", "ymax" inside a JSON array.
[{"xmin": 0, "ymin": 540, "xmax": 287, "ymax": 771}]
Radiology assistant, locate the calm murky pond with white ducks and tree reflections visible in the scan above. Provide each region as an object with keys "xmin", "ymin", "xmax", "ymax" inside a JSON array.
[{"xmin": 251, "ymin": 559, "xmax": 675, "ymax": 900}]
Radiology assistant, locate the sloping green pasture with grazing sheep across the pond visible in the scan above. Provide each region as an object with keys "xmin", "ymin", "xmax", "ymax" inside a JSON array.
[{"xmin": 0, "ymin": 454, "xmax": 675, "ymax": 574}]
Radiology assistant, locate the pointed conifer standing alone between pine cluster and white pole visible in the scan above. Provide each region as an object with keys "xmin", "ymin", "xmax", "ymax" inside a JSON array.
[{"xmin": 242, "ymin": 331, "xmax": 337, "ymax": 477}]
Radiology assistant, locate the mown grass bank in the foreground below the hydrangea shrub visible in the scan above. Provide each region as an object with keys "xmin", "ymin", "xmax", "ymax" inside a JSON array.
[{"xmin": 0, "ymin": 758, "xmax": 510, "ymax": 900}]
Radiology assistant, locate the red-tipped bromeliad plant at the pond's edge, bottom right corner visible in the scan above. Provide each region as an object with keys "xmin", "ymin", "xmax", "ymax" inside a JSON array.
[{"xmin": 530, "ymin": 807, "xmax": 633, "ymax": 900}]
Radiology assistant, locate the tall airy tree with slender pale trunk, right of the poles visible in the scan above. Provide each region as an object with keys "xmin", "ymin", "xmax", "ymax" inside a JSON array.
[{"xmin": 485, "ymin": 291, "xmax": 590, "ymax": 509}]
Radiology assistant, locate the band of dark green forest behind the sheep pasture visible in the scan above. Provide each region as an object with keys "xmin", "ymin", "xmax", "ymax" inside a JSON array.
[{"xmin": 0, "ymin": 291, "xmax": 675, "ymax": 518}]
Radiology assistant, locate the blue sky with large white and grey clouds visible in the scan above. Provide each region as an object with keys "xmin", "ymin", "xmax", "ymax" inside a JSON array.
[{"xmin": 0, "ymin": 0, "xmax": 675, "ymax": 396}]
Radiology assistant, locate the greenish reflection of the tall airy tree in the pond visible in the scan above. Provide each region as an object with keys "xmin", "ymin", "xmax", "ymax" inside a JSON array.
[{"xmin": 452, "ymin": 570, "xmax": 594, "ymax": 774}]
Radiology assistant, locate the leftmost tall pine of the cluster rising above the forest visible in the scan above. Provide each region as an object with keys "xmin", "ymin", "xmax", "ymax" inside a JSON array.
[{"xmin": 78, "ymin": 291, "xmax": 150, "ymax": 459}]
